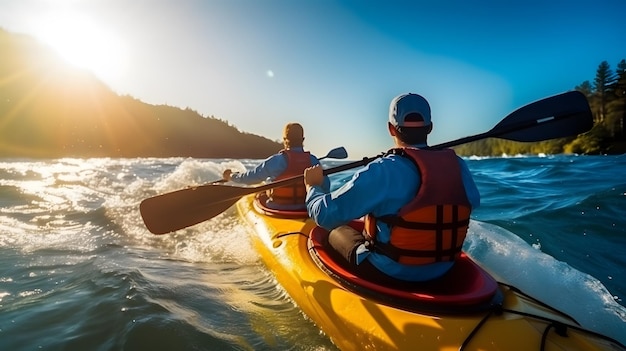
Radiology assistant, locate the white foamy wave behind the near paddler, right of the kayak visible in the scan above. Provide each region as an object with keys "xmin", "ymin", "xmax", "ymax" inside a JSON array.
[{"xmin": 463, "ymin": 221, "xmax": 626, "ymax": 344}]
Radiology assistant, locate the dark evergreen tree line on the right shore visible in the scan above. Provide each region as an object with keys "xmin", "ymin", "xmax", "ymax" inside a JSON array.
[{"xmin": 454, "ymin": 59, "xmax": 626, "ymax": 156}]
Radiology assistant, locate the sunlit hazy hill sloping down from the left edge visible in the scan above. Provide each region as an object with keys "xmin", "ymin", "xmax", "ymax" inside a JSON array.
[{"xmin": 0, "ymin": 29, "xmax": 282, "ymax": 158}]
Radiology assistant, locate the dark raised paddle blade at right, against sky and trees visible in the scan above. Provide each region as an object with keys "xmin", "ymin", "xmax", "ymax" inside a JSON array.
[{"xmin": 487, "ymin": 91, "xmax": 593, "ymax": 141}]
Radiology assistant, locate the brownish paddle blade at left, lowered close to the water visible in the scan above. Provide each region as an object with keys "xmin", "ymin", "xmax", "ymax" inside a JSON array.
[{"xmin": 139, "ymin": 184, "xmax": 255, "ymax": 234}]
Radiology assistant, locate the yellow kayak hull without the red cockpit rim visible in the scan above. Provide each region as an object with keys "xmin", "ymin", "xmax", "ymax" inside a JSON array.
[{"xmin": 237, "ymin": 195, "xmax": 623, "ymax": 351}]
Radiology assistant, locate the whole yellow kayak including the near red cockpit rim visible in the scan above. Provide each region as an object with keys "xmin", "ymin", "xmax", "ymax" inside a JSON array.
[{"xmin": 236, "ymin": 195, "xmax": 626, "ymax": 351}]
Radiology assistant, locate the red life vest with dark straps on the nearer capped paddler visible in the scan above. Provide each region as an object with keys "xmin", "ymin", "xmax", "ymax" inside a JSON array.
[{"xmin": 365, "ymin": 148, "xmax": 471, "ymax": 265}]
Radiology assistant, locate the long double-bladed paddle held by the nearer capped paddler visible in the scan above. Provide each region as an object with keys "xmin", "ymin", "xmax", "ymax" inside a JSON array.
[{"xmin": 140, "ymin": 91, "xmax": 593, "ymax": 234}]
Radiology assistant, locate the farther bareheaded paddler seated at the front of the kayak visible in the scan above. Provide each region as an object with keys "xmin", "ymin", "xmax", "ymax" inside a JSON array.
[{"xmin": 222, "ymin": 123, "xmax": 330, "ymax": 210}]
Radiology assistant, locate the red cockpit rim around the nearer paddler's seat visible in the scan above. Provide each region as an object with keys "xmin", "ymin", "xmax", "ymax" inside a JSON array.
[{"xmin": 308, "ymin": 221, "xmax": 503, "ymax": 314}]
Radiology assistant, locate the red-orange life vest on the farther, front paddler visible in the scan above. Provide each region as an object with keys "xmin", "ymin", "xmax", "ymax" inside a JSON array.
[{"xmin": 267, "ymin": 150, "xmax": 312, "ymax": 205}]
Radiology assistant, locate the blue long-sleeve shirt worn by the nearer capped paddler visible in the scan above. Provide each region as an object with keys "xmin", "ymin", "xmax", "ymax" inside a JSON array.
[{"xmin": 306, "ymin": 150, "xmax": 480, "ymax": 281}]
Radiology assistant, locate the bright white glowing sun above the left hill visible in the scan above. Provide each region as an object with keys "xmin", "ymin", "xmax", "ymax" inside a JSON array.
[{"xmin": 33, "ymin": 11, "xmax": 127, "ymax": 83}]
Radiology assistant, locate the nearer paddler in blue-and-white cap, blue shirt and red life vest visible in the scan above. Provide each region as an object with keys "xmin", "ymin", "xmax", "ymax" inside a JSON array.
[{"xmin": 304, "ymin": 94, "xmax": 480, "ymax": 281}]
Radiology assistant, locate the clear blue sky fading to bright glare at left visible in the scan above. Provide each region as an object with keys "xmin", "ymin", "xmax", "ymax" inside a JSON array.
[{"xmin": 0, "ymin": 0, "xmax": 626, "ymax": 159}]
